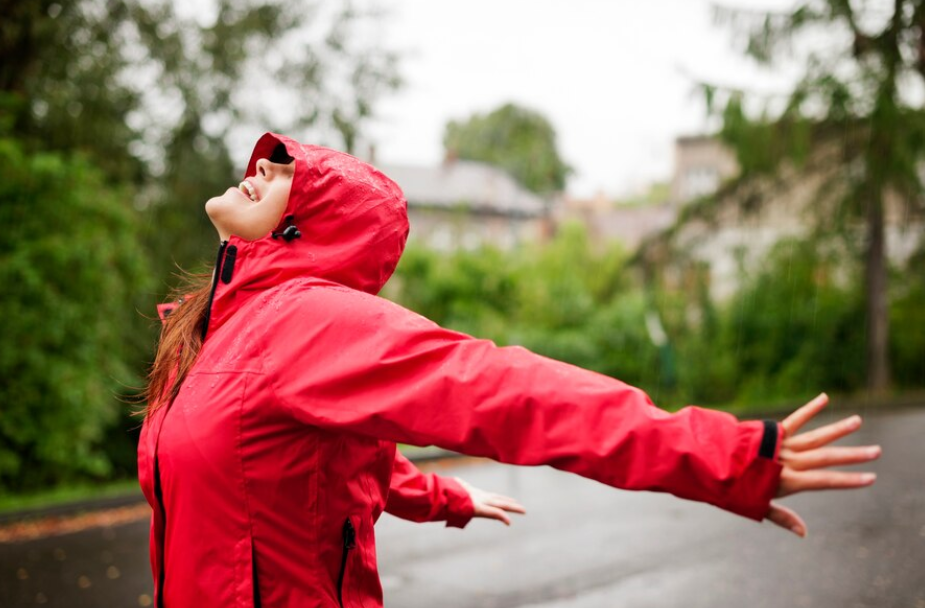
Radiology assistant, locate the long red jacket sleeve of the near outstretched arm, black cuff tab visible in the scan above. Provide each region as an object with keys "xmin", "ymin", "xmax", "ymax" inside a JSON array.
[{"xmin": 263, "ymin": 284, "xmax": 781, "ymax": 520}]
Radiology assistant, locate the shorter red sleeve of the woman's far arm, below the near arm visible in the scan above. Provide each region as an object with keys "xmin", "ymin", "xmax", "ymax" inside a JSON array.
[{"xmin": 385, "ymin": 452, "xmax": 474, "ymax": 528}]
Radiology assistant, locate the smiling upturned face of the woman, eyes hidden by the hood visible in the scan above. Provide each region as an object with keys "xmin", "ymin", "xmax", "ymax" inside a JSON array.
[{"xmin": 206, "ymin": 158, "xmax": 295, "ymax": 241}]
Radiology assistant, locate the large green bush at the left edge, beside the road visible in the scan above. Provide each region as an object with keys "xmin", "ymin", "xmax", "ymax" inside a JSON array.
[{"xmin": 0, "ymin": 138, "xmax": 150, "ymax": 490}]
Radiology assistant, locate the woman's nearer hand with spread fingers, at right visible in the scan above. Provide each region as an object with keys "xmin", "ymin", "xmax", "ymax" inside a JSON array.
[{"xmin": 766, "ymin": 393, "xmax": 881, "ymax": 537}]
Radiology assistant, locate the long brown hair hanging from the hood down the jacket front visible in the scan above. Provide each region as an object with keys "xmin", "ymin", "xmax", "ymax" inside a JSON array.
[{"xmin": 143, "ymin": 274, "xmax": 212, "ymax": 416}]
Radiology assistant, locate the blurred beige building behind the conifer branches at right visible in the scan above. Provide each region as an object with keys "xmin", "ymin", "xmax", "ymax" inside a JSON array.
[{"xmin": 637, "ymin": 144, "xmax": 925, "ymax": 300}]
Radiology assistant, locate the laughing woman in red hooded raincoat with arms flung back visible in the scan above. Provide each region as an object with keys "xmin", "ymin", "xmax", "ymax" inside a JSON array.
[{"xmin": 138, "ymin": 134, "xmax": 879, "ymax": 608}]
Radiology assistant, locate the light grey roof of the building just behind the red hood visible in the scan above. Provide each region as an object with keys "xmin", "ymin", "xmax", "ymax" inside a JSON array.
[{"xmin": 379, "ymin": 160, "xmax": 546, "ymax": 217}]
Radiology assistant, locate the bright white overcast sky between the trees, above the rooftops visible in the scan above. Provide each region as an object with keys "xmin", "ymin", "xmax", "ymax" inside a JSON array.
[{"xmin": 370, "ymin": 0, "xmax": 790, "ymax": 197}]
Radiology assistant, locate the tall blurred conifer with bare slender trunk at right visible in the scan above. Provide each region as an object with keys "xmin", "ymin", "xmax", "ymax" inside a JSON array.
[{"xmin": 705, "ymin": 0, "xmax": 925, "ymax": 392}]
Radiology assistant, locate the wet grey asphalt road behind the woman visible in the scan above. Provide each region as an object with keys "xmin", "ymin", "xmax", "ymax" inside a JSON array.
[{"xmin": 0, "ymin": 409, "xmax": 925, "ymax": 608}]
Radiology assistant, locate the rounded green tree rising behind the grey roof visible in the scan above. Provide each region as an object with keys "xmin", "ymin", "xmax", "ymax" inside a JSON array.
[{"xmin": 443, "ymin": 103, "xmax": 572, "ymax": 194}]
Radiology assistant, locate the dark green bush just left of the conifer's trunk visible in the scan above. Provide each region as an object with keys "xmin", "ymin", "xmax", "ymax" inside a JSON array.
[{"xmin": 721, "ymin": 241, "xmax": 865, "ymax": 401}]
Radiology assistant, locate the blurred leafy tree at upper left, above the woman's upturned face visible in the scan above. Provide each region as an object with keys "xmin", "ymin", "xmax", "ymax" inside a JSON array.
[{"xmin": 0, "ymin": 0, "xmax": 400, "ymax": 275}]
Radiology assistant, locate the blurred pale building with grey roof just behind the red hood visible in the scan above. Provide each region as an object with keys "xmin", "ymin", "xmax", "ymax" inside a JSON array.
[{"xmin": 377, "ymin": 158, "xmax": 551, "ymax": 251}]
